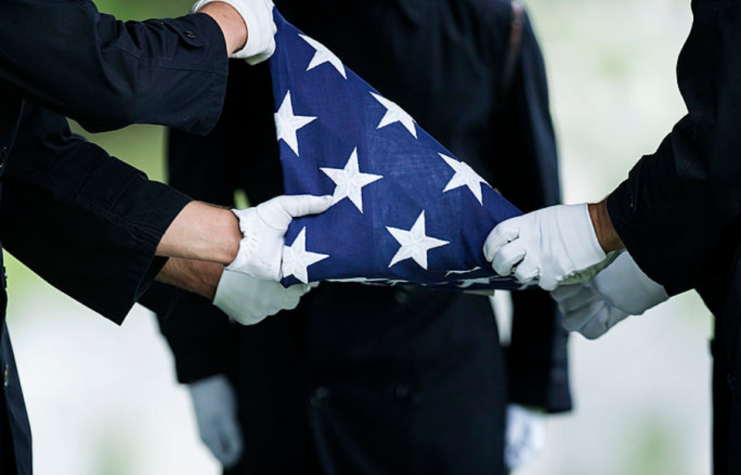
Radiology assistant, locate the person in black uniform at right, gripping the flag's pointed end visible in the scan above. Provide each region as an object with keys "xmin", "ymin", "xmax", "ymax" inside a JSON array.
[{"xmin": 485, "ymin": 0, "xmax": 741, "ymax": 475}]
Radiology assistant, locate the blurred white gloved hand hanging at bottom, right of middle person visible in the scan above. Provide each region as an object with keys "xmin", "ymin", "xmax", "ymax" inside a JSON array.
[{"xmin": 504, "ymin": 404, "xmax": 546, "ymax": 471}]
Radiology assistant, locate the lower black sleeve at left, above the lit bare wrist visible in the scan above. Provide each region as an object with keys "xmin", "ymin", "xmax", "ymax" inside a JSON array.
[{"xmin": 0, "ymin": 105, "xmax": 190, "ymax": 323}]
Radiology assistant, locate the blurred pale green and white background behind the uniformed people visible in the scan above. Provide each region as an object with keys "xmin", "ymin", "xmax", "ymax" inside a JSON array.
[{"xmin": 8, "ymin": 0, "xmax": 711, "ymax": 475}]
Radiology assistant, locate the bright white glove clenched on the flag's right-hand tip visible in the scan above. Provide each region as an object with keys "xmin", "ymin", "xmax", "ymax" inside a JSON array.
[{"xmin": 484, "ymin": 204, "xmax": 607, "ymax": 290}]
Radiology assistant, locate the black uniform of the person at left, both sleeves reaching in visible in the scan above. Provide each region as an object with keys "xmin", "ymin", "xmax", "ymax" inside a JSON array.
[{"xmin": 0, "ymin": 0, "xmax": 228, "ymax": 475}]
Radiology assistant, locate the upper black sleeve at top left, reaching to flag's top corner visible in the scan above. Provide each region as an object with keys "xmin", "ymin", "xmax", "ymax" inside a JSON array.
[{"xmin": 0, "ymin": 0, "xmax": 227, "ymax": 134}]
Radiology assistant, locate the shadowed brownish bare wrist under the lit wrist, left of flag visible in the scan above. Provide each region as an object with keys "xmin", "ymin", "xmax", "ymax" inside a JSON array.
[{"xmin": 157, "ymin": 258, "xmax": 224, "ymax": 301}]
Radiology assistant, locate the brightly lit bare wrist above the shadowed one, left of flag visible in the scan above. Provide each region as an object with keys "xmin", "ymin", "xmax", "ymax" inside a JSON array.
[{"xmin": 157, "ymin": 202, "xmax": 242, "ymax": 265}]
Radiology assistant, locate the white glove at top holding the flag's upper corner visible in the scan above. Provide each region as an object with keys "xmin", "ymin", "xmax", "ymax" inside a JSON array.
[{"xmin": 191, "ymin": 0, "xmax": 278, "ymax": 65}]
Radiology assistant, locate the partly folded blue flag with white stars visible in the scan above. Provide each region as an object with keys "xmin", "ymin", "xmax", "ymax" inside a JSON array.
[{"xmin": 270, "ymin": 10, "xmax": 521, "ymax": 290}]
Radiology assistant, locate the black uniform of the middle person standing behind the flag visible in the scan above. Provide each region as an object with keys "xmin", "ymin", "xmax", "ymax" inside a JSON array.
[{"xmin": 153, "ymin": 0, "xmax": 571, "ymax": 475}]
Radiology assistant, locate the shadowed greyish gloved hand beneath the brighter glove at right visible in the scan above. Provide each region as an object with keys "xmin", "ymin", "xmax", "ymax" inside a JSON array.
[{"xmin": 551, "ymin": 252, "xmax": 669, "ymax": 340}]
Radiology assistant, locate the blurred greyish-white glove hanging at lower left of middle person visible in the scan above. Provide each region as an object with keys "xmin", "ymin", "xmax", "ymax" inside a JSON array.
[{"xmin": 188, "ymin": 375, "xmax": 243, "ymax": 468}]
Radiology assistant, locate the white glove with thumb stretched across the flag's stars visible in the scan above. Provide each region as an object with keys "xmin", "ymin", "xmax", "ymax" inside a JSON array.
[{"xmin": 227, "ymin": 195, "xmax": 332, "ymax": 282}]
